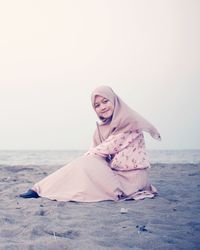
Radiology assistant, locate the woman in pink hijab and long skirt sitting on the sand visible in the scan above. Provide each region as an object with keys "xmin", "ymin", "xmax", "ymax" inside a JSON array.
[{"xmin": 20, "ymin": 86, "xmax": 160, "ymax": 202}]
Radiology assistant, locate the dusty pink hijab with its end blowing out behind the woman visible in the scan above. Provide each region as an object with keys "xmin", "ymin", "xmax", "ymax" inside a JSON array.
[{"xmin": 91, "ymin": 86, "xmax": 161, "ymax": 146}]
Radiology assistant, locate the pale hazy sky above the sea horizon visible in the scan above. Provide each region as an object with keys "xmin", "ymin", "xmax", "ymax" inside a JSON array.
[{"xmin": 0, "ymin": 0, "xmax": 200, "ymax": 150}]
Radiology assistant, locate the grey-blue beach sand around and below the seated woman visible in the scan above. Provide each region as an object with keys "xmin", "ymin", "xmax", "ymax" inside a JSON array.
[{"xmin": 0, "ymin": 164, "xmax": 200, "ymax": 250}]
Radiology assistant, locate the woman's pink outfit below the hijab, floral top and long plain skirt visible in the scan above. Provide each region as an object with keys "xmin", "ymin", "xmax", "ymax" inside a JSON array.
[{"xmin": 32, "ymin": 131, "xmax": 157, "ymax": 202}]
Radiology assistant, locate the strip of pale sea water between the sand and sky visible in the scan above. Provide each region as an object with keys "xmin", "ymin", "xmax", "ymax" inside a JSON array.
[{"xmin": 0, "ymin": 150, "xmax": 200, "ymax": 166}]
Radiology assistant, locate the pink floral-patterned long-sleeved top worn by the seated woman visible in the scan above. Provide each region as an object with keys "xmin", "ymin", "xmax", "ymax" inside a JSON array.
[{"xmin": 87, "ymin": 131, "xmax": 150, "ymax": 171}]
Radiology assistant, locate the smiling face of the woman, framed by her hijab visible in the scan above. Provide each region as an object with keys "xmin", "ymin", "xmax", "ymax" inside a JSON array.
[{"xmin": 94, "ymin": 95, "xmax": 114, "ymax": 119}]
